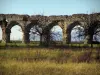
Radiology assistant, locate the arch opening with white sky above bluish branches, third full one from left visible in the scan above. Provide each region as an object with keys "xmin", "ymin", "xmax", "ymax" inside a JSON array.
[{"xmin": 50, "ymin": 25, "xmax": 63, "ymax": 42}]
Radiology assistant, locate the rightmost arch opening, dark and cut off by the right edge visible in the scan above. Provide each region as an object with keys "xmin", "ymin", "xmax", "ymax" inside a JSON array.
[{"xmin": 88, "ymin": 21, "xmax": 100, "ymax": 44}]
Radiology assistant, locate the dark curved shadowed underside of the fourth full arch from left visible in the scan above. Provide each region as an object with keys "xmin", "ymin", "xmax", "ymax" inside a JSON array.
[{"xmin": 66, "ymin": 21, "xmax": 84, "ymax": 44}]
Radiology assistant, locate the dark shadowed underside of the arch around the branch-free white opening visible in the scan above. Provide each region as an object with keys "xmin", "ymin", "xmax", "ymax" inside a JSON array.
[{"xmin": 6, "ymin": 21, "xmax": 24, "ymax": 43}]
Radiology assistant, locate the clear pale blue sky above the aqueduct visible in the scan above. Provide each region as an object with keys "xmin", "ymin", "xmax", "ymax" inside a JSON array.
[{"xmin": 0, "ymin": 0, "xmax": 100, "ymax": 39}]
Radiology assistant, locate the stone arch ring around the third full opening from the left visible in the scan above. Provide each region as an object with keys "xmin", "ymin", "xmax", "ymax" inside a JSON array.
[{"xmin": 40, "ymin": 20, "xmax": 66, "ymax": 44}]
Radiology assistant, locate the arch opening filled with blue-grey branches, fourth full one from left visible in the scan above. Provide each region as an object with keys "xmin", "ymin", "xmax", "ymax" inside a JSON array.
[{"xmin": 71, "ymin": 25, "xmax": 85, "ymax": 43}]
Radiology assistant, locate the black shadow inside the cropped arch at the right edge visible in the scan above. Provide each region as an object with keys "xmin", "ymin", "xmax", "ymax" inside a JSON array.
[{"xmin": 87, "ymin": 20, "xmax": 100, "ymax": 44}]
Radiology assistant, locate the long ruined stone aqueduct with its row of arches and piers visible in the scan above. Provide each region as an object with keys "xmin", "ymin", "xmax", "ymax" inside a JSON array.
[{"xmin": 0, "ymin": 13, "xmax": 100, "ymax": 44}]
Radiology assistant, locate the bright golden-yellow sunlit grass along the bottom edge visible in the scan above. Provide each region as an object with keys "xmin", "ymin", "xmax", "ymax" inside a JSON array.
[{"xmin": 0, "ymin": 61, "xmax": 100, "ymax": 75}]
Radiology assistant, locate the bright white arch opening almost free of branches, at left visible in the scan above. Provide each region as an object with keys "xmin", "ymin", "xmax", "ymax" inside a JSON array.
[{"xmin": 10, "ymin": 25, "xmax": 23, "ymax": 41}]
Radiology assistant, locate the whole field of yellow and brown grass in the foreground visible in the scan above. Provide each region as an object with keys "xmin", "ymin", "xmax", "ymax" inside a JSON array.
[{"xmin": 0, "ymin": 48, "xmax": 100, "ymax": 75}]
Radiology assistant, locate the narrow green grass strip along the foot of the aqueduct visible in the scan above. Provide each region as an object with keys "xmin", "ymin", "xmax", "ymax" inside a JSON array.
[{"xmin": 0, "ymin": 42, "xmax": 100, "ymax": 48}]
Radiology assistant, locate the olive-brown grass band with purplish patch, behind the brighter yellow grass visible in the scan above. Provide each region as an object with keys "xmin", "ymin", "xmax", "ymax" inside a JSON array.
[{"xmin": 0, "ymin": 48, "xmax": 100, "ymax": 63}]
